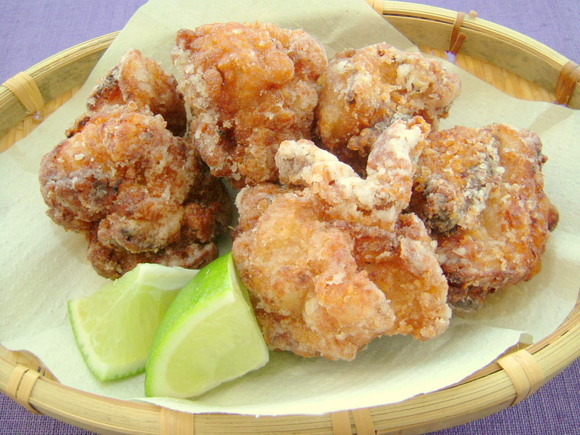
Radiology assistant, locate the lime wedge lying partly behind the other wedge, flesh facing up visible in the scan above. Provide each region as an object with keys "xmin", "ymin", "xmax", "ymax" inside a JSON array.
[{"xmin": 68, "ymin": 263, "xmax": 198, "ymax": 381}]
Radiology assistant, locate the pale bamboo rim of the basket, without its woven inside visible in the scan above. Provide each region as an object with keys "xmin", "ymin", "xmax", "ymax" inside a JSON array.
[{"xmin": 0, "ymin": 0, "xmax": 580, "ymax": 434}]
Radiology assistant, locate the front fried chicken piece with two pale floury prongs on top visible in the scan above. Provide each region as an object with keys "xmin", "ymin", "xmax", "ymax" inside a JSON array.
[{"xmin": 232, "ymin": 122, "xmax": 450, "ymax": 360}]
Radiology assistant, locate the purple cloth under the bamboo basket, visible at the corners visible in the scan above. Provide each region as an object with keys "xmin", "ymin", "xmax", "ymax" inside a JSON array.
[{"xmin": 0, "ymin": 0, "xmax": 580, "ymax": 435}]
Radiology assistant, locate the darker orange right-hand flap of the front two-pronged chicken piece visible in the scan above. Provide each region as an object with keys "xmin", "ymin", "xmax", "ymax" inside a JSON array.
[{"xmin": 349, "ymin": 213, "xmax": 451, "ymax": 340}]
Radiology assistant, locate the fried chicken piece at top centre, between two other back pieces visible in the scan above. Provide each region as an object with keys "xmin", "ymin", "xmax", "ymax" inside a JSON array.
[{"xmin": 173, "ymin": 23, "xmax": 327, "ymax": 188}]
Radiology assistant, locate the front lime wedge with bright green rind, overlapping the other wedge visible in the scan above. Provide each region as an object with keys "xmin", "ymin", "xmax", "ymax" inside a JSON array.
[{"xmin": 145, "ymin": 254, "xmax": 269, "ymax": 398}]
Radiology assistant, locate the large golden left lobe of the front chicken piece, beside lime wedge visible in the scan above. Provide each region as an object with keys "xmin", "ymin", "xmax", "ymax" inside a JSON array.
[{"xmin": 232, "ymin": 184, "xmax": 394, "ymax": 360}]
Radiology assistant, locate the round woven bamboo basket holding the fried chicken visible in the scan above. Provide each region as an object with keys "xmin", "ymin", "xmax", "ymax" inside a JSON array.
[{"xmin": 0, "ymin": 0, "xmax": 580, "ymax": 434}]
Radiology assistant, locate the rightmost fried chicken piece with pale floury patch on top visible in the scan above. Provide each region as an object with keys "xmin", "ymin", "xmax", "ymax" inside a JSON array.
[{"xmin": 410, "ymin": 124, "xmax": 558, "ymax": 311}]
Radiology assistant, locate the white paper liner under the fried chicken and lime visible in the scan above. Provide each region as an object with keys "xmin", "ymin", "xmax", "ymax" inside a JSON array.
[{"xmin": 0, "ymin": 0, "xmax": 580, "ymax": 415}]
